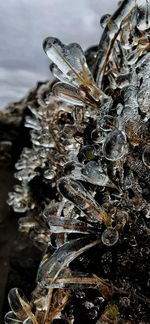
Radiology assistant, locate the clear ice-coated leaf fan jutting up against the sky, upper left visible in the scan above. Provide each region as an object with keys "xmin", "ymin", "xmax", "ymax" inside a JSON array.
[{"xmin": 43, "ymin": 37, "xmax": 107, "ymax": 102}]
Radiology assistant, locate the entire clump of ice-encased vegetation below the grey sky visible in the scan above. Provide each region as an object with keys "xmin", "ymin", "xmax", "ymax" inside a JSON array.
[{"xmin": 2, "ymin": 0, "xmax": 150, "ymax": 324}]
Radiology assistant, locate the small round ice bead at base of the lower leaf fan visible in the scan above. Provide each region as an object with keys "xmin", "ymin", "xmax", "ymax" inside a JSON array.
[{"xmin": 101, "ymin": 228, "xmax": 119, "ymax": 246}]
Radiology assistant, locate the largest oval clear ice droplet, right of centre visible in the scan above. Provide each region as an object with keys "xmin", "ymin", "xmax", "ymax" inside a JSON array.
[{"xmin": 103, "ymin": 129, "xmax": 126, "ymax": 161}]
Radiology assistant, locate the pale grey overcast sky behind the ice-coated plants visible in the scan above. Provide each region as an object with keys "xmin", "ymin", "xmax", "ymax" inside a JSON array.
[{"xmin": 0, "ymin": 0, "xmax": 118, "ymax": 109}]
